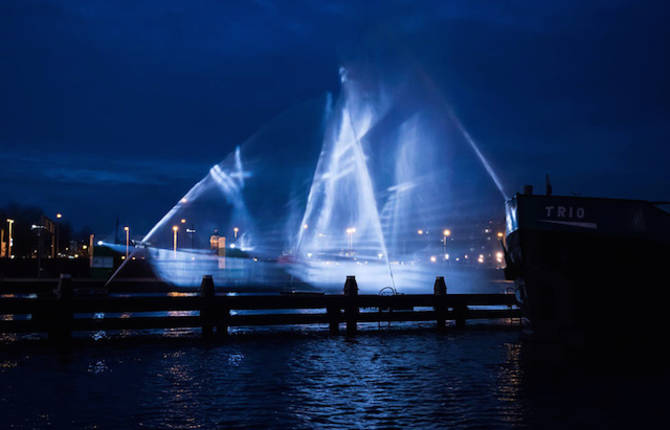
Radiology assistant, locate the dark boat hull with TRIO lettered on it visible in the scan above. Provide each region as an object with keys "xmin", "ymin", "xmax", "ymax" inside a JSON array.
[{"xmin": 506, "ymin": 195, "xmax": 670, "ymax": 345}]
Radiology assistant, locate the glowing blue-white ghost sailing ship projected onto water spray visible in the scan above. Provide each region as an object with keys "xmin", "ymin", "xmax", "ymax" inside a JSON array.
[{"xmin": 107, "ymin": 68, "xmax": 505, "ymax": 293}]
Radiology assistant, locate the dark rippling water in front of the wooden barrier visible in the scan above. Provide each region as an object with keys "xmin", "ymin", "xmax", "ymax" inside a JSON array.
[{"xmin": 0, "ymin": 329, "xmax": 670, "ymax": 429}]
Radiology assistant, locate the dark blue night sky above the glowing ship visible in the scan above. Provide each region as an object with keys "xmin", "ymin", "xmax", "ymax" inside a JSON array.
[{"xmin": 0, "ymin": 0, "xmax": 670, "ymax": 232}]
